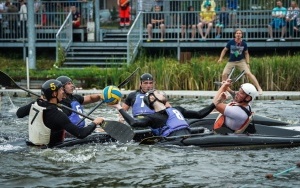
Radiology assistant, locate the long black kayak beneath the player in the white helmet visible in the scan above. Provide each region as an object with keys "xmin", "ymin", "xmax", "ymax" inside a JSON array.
[{"xmin": 140, "ymin": 125, "xmax": 300, "ymax": 149}]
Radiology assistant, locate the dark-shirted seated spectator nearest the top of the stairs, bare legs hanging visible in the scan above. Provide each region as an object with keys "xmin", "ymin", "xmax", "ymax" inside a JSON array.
[{"xmin": 147, "ymin": 5, "xmax": 166, "ymax": 42}]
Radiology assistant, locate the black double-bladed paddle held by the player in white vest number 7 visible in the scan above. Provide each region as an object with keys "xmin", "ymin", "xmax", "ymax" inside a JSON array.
[{"xmin": 0, "ymin": 71, "xmax": 134, "ymax": 143}]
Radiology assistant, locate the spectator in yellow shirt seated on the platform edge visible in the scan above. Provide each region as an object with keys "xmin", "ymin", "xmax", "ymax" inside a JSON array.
[{"xmin": 197, "ymin": 4, "xmax": 216, "ymax": 41}]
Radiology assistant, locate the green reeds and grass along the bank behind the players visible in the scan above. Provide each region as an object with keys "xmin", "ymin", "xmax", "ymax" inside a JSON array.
[{"xmin": 0, "ymin": 50, "xmax": 300, "ymax": 91}]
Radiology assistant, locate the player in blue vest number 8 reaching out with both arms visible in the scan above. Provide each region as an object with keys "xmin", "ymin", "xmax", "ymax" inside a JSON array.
[{"xmin": 110, "ymin": 90, "xmax": 218, "ymax": 136}]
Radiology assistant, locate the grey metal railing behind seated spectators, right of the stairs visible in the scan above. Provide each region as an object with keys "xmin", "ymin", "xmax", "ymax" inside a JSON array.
[{"xmin": 142, "ymin": 10, "xmax": 300, "ymax": 42}]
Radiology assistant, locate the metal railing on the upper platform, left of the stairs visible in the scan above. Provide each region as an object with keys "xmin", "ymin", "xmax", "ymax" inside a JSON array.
[{"xmin": 0, "ymin": 1, "xmax": 93, "ymax": 41}]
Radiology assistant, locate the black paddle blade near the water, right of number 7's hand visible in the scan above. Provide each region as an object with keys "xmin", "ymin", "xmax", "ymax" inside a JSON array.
[{"xmin": 101, "ymin": 121, "xmax": 134, "ymax": 143}]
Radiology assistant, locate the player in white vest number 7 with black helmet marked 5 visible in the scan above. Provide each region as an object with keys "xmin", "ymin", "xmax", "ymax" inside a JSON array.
[{"xmin": 16, "ymin": 79, "xmax": 104, "ymax": 147}]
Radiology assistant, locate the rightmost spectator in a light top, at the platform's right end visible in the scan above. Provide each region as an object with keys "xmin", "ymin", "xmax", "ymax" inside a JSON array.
[{"xmin": 285, "ymin": 1, "xmax": 299, "ymax": 38}]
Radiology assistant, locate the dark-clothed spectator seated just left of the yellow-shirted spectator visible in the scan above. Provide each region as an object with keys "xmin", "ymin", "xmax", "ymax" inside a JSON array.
[{"xmin": 181, "ymin": 6, "xmax": 199, "ymax": 41}]
